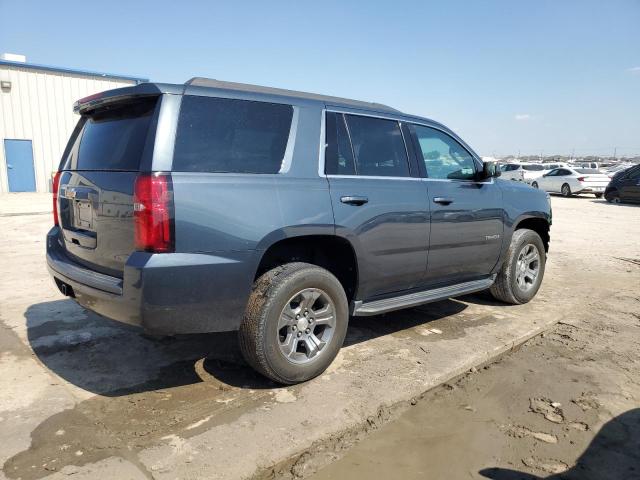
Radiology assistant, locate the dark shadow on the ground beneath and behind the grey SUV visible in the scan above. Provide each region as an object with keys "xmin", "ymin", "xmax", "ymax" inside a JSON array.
[{"xmin": 25, "ymin": 299, "xmax": 467, "ymax": 397}]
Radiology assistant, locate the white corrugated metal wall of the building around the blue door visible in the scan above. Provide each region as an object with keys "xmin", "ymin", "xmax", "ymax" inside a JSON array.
[{"xmin": 0, "ymin": 65, "xmax": 135, "ymax": 192}]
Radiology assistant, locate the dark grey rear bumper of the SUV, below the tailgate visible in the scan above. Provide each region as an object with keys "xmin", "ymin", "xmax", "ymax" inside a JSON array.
[{"xmin": 47, "ymin": 227, "xmax": 256, "ymax": 334}]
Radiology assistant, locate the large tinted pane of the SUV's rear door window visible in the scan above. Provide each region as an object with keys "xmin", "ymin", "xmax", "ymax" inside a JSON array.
[{"xmin": 345, "ymin": 115, "xmax": 409, "ymax": 177}]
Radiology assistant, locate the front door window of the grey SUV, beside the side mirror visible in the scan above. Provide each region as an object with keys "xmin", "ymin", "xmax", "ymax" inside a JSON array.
[{"xmin": 415, "ymin": 125, "xmax": 478, "ymax": 180}]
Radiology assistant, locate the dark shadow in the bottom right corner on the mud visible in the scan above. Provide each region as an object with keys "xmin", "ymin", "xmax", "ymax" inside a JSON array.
[{"xmin": 479, "ymin": 408, "xmax": 640, "ymax": 480}]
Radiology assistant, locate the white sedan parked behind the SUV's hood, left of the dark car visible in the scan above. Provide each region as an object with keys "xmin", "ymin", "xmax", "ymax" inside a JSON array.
[{"xmin": 531, "ymin": 167, "xmax": 609, "ymax": 198}]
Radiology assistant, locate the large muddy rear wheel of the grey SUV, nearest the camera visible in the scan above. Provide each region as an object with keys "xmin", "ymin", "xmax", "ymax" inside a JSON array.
[{"xmin": 238, "ymin": 262, "xmax": 349, "ymax": 385}]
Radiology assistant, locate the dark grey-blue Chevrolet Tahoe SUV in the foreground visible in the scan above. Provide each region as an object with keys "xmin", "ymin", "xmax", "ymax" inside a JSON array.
[{"xmin": 47, "ymin": 78, "xmax": 551, "ymax": 384}]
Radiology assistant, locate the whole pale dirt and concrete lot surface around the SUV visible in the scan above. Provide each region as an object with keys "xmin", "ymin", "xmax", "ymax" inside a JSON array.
[{"xmin": 0, "ymin": 196, "xmax": 640, "ymax": 479}]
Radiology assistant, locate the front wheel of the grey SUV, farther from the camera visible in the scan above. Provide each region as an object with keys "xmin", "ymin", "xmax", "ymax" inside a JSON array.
[{"xmin": 490, "ymin": 228, "xmax": 546, "ymax": 305}]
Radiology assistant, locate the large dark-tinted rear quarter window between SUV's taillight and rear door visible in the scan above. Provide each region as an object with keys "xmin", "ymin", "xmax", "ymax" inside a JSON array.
[{"xmin": 173, "ymin": 95, "xmax": 293, "ymax": 173}]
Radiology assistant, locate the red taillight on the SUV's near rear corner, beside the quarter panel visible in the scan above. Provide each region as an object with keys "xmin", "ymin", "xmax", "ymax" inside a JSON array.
[{"xmin": 133, "ymin": 173, "xmax": 175, "ymax": 253}]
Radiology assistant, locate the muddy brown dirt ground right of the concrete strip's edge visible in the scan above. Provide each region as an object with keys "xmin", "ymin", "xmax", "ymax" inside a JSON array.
[{"xmin": 311, "ymin": 198, "xmax": 640, "ymax": 480}]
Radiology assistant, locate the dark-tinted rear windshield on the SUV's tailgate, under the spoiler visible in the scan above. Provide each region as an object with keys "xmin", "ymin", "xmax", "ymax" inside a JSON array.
[{"xmin": 64, "ymin": 97, "xmax": 157, "ymax": 170}]
